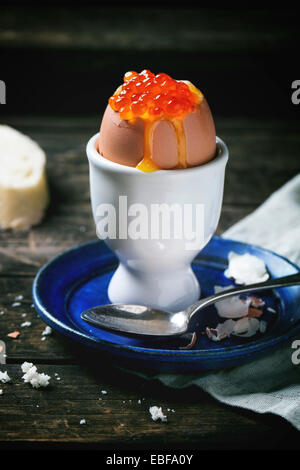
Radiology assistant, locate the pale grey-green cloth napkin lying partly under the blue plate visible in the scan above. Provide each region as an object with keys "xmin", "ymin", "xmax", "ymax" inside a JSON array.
[{"xmin": 129, "ymin": 174, "xmax": 300, "ymax": 430}]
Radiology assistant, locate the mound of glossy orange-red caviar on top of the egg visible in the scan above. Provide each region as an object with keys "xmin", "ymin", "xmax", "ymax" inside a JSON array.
[{"xmin": 109, "ymin": 70, "xmax": 203, "ymax": 121}]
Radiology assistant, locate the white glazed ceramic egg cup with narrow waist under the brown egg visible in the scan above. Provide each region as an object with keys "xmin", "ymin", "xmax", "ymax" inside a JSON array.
[{"xmin": 87, "ymin": 134, "xmax": 228, "ymax": 311}]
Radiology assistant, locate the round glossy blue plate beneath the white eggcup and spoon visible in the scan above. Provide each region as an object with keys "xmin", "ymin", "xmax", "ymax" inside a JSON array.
[{"xmin": 33, "ymin": 237, "xmax": 300, "ymax": 372}]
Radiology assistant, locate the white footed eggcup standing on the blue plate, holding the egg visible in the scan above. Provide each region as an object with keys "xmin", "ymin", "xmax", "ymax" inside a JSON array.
[{"xmin": 87, "ymin": 134, "xmax": 228, "ymax": 311}]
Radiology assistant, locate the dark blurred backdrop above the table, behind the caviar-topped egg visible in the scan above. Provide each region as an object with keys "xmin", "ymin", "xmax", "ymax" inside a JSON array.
[{"xmin": 0, "ymin": 1, "xmax": 299, "ymax": 119}]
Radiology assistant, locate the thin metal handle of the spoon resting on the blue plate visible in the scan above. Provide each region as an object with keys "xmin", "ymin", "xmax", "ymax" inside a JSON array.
[{"xmin": 186, "ymin": 272, "xmax": 300, "ymax": 318}]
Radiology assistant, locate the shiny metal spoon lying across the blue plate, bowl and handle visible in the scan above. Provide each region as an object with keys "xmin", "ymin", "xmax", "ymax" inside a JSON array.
[{"xmin": 81, "ymin": 272, "xmax": 300, "ymax": 338}]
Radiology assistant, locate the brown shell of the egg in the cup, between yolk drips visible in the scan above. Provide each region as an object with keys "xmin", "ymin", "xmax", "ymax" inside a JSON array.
[{"xmin": 98, "ymin": 99, "xmax": 216, "ymax": 170}]
